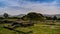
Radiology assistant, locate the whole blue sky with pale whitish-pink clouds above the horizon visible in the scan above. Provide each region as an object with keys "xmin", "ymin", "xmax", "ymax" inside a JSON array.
[{"xmin": 0, "ymin": 0, "xmax": 60, "ymax": 15}]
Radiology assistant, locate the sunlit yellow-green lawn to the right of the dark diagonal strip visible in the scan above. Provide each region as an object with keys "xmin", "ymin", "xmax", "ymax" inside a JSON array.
[{"xmin": 17, "ymin": 24, "xmax": 60, "ymax": 34}]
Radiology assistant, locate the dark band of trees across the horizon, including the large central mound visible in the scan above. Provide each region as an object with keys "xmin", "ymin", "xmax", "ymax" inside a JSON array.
[{"xmin": 0, "ymin": 12, "xmax": 60, "ymax": 20}]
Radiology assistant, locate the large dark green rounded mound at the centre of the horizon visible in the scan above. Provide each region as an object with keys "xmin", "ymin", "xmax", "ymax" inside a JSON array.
[{"xmin": 26, "ymin": 12, "xmax": 44, "ymax": 20}]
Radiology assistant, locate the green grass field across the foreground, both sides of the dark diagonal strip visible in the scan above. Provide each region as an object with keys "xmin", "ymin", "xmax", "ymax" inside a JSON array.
[{"xmin": 0, "ymin": 22, "xmax": 60, "ymax": 34}]
